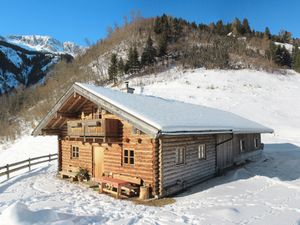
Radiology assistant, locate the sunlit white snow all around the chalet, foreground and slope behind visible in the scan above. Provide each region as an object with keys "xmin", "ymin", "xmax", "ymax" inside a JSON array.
[{"xmin": 0, "ymin": 69, "xmax": 300, "ymax": 224}]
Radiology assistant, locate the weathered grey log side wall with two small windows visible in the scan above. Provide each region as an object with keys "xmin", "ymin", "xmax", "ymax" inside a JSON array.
[{"xmin": 160, "ymin": 135, "xmax": 216, "ymax": 196}]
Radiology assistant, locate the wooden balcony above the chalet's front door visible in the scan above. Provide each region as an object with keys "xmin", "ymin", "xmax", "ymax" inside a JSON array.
[{"xmin": 67, "ymin": 119, "xmax": 120, "ymax": 137}]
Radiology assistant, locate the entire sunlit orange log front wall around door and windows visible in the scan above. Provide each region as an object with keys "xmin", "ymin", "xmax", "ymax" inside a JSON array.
[{"xmin": 60, "ymin": 102, "xmax": 158, "ymax": 195}]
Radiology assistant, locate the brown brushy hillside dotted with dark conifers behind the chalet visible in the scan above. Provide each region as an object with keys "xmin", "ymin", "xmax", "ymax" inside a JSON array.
[{"xmin": 0, "ymin": 15, "xmax": 300, "ymax": 142}]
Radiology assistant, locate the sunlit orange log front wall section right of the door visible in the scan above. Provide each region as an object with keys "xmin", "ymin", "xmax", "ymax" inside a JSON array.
[{"xmin": 102, "ymin": 113, "xmax": 157, "ymax": 195}]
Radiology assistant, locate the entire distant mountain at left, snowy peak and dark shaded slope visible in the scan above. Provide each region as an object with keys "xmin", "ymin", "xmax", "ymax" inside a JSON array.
[{"xmin": 0, "ymin": 35, "xmax": 85, "ymax": 95}]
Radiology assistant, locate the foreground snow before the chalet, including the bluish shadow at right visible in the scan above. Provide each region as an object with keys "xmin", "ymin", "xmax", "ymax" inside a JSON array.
[{"xmin": 0, "ymin": 144, "xmax": 300, "ymax": 224}]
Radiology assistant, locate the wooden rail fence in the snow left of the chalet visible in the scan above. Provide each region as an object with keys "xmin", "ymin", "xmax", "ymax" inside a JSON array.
[{"xmin": 0, "ymin": 154, "xmax": 57, "ymax": 180}]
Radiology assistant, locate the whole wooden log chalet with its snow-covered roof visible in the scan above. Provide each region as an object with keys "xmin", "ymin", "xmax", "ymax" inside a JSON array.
[{"xmin": 33, "ymin": 83, "xmax": 273, "ymax": 197}]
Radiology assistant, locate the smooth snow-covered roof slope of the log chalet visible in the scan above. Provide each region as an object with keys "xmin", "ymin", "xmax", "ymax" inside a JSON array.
[{"xmin": 76, "ymin": 83, "xmax": 273, "ymax": 134}]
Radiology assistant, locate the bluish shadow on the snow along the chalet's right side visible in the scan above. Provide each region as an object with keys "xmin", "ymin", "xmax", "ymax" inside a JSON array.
[{"xmin": 178, "ymin": 143, "xmax": 300, "ymax": 197}]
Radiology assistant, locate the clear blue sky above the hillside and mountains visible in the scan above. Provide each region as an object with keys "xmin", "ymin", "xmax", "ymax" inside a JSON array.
[{"xmin": 0, "ymin": 0, "xmax": 300, "ymax": 45}]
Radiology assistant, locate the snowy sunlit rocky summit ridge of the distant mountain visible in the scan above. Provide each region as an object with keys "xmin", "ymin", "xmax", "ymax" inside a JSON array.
[{"xmin": 4, "ymin": 35, "xmax": 85, "ymax": 57}]
